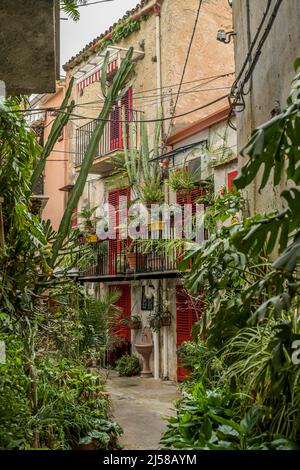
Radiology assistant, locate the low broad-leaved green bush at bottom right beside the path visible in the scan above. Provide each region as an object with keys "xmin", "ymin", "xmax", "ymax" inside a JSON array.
[{"xmin": 161, "ymin": 383, "xmax": 299, "ymax": 450}]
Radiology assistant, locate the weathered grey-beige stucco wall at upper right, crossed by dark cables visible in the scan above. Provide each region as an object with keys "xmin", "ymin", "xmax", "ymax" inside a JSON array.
[{"xmin": 233, "ymin": 0, "xmax": 300, "ymax": 213}]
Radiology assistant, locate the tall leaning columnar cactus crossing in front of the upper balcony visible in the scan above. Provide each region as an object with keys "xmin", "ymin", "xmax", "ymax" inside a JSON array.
[{"xmin": 50, "ymin": 48, "xmax": 134, "ymax": 267}]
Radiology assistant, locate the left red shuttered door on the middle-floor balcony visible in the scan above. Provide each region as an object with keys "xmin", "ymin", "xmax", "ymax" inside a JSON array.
[{"xmin": 108, "ymin": 188, "xmax": 130, "ymax": 275}]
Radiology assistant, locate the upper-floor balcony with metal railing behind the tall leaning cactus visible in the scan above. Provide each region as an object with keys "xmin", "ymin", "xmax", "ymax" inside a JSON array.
[{"xmin": 75, "ymin": 106, "xmax": 142, "ymax": 174}]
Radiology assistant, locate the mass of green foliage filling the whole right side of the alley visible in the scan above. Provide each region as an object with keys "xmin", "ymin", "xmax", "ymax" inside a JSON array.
[{"xmin": 162, "ymin": 60, "xmax": 300, "ymax": 450}]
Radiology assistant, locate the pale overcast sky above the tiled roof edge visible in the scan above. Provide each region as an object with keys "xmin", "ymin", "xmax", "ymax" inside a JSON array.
[{"xmin": 60, "ymin": 0, "xmax": 139, "ymax": 74}]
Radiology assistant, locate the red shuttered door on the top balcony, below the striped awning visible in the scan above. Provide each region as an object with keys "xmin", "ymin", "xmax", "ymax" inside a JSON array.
[{"xmin": 110, "ymin": 87, "xmax": 132, "ymax": 152}]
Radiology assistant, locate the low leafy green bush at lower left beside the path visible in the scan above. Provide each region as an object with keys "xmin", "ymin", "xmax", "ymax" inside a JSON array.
[{"xmin": 29, "ymin": 359, "xmax": 122, "ymax": 450}]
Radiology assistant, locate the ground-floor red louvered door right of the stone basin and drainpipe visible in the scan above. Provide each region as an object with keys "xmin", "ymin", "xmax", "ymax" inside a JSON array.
[{"xmin": 176, "ymin": 286, "xmax": 202, "ymax": 382}]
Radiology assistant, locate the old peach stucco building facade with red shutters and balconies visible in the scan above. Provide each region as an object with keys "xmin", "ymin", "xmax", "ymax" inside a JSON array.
[{"xmin": 64, "ymin": 0, "xmax": 236, "ymax": 380}]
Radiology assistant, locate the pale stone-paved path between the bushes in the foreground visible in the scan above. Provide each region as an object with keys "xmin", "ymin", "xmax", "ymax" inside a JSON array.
[{"xmin": 107, "ymin": 372, "xmax": 179, "ymax": 450}]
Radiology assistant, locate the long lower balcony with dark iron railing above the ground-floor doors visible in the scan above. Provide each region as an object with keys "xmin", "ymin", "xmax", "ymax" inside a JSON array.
[{"xmin": 79, "ymin": 240, "xmax": 178, "ymax": 282}]
